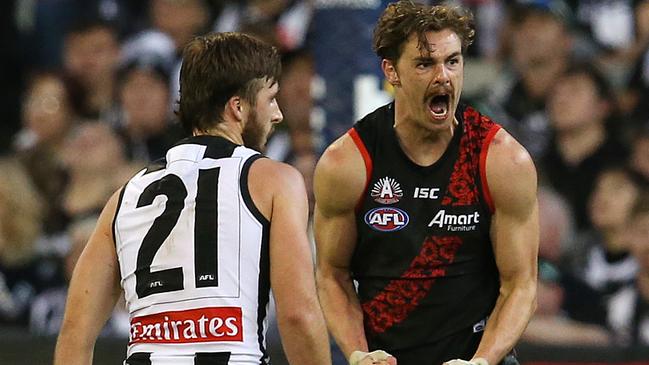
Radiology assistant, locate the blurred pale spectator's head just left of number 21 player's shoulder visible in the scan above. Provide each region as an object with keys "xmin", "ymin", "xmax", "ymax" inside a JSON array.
[{"xmin": 62, "ymin": 122, "xmax": 139, "ymax": 221}]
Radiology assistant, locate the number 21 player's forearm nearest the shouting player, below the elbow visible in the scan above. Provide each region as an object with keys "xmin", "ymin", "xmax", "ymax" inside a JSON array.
[{"xmin": 277, "ymin": 305, "xmax": 331, "ymax": 365}]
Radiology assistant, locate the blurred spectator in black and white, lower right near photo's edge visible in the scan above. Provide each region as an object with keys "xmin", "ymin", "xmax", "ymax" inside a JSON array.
[{"xmin": 572, "ymin": 167, "xmax": 641, "ymax": 303}]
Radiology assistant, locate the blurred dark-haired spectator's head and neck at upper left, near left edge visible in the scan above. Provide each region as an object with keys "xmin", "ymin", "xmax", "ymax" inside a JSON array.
[{"xmin": 63, "ymin": 19, "xmax": 119, "ymax": 120}]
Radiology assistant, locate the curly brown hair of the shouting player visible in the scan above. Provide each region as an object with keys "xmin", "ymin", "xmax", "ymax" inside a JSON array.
[{"xmin": 373, "ymin": 0, "xmax": 475, "ymax": 61}]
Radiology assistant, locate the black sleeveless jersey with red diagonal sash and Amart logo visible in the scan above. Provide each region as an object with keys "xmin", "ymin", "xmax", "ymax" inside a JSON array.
[{"xmin": 348, "ymin": 104, "xmax": 500, "ymax": 351}]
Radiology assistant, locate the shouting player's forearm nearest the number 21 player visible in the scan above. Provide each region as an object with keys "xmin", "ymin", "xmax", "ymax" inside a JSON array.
[{"xmin": 316, "ymin": 271, "xmax": 368, "ymax": 358}]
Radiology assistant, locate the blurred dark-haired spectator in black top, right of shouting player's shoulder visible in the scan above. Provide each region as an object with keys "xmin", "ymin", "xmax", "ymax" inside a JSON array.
[{"xmin": 540, "ymin": 64, "xmax": 627, "ymax": 230}]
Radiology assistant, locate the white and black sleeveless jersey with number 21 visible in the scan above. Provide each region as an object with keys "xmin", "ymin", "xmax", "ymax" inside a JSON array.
[{"xmin": 113, "ymin": 136, "xmax": 270, "ymax": 365}]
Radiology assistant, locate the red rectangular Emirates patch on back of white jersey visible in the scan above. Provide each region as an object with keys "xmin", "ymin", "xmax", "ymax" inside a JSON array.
[{"xmin": 129, "ymin": 307, "xmax": 243, "ymax": 344}]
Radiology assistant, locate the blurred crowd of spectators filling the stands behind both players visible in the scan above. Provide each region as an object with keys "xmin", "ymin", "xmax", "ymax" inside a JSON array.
[{"xmin": 0, "ymin": 0, "xmax": 649, "ymax": 352}]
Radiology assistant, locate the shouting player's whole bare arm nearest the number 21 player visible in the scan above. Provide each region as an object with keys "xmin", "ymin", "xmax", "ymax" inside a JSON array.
[{"xmin": 314, "ymin": 136, "xmax": 367, "ymax": 358}]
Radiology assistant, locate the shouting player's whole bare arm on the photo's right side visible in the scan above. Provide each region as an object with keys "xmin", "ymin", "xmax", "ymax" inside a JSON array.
[{"xmin": 474, "ymin": 130, "xmax": 539, "ymax": 365}]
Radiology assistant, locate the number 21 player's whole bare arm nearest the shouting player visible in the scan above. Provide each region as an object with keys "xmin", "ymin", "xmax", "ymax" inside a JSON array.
[{"xmin": 249, "ymin": 159, "xmax": 331, "ymax": 365}]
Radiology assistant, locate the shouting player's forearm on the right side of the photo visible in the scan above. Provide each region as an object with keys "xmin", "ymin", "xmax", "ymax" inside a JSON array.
[{"xmin": 474, "ymin": 280, "xmax": 536, "ymax": 365}]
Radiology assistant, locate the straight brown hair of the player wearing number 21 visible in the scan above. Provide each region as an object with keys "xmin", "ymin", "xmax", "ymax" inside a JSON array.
[{"xmin": 178, "ymin": 32, "xmax": 281, "ymax": 133}]
